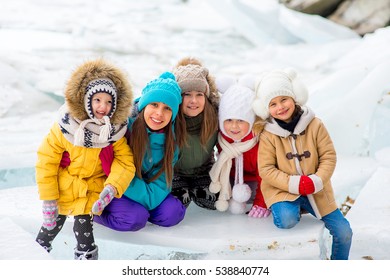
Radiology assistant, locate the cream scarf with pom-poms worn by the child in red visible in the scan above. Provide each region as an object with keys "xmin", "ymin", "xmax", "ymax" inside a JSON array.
[{"xmin": 209, "ymin": 133, "xmax": 258, "ymax": 201}]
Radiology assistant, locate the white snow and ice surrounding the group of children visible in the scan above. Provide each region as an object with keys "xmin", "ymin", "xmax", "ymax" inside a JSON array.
[{"xmin": 0, "ymin": 0, "xmax": 390, "ymax": 279}]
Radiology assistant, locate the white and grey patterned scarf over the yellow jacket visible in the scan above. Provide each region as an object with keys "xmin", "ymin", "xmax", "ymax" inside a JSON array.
[{"xmin": 58, "ymin": 104, "xmax": 127, "ymax": 148}]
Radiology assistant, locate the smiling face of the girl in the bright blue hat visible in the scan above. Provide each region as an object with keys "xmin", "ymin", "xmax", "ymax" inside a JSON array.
[{"xmin": 144, "ymin": 102, "xmax": 172, "ymax": 131}]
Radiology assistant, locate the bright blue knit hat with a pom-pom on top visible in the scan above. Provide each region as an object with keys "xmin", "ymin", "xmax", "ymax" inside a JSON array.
[{"xmin": 138, "ymin": 72, "xmax": 182, "ymax": 120}]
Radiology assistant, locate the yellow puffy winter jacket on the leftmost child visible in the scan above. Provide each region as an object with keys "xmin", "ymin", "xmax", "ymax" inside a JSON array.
[{"xmin": 36, "ymin": 123, "xmax": 135, "ymax": 216}]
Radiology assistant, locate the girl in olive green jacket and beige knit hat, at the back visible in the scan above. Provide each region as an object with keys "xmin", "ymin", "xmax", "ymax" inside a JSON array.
[{"xmin": 172, "ymin": 57, "xmax": 219, "ymax": 210}]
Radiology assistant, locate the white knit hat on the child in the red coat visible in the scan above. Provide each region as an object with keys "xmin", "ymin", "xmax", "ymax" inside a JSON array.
[{"xmin": 216, "ymin": 75, "xmax": 255, "ymax": 140}]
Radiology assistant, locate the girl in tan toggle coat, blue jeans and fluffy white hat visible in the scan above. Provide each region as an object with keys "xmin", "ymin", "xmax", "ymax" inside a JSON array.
[{"xmin": 253, "ymin": 69, "xmax": 352, "ymax": 259}]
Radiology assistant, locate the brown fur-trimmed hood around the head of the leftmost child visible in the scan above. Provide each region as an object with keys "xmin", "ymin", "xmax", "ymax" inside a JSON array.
[{"xmin": 64, "ymin": 59, "xmax": 133, "ymax": 125}]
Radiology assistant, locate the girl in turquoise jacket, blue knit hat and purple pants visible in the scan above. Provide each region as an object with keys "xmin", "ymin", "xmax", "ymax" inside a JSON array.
[{"xmin": 95, "ymin": 72, "xmax": 186, "ymax": 231}]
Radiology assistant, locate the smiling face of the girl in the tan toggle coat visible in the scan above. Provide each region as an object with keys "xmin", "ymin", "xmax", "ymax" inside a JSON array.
[{"xmin": 268, "ymin": 96, "xmax": 295, "ymax": 123}]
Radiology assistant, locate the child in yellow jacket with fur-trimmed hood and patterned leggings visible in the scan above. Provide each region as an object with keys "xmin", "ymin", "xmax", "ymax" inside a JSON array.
[{"xmin": 36, "ymin": 59, "xmax": 135, "ymax": 259}]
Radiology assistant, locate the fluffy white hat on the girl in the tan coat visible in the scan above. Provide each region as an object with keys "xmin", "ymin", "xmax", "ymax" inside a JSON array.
[{"xmin": 252, "ymin": 68, "xmax": 308, "ymax": 120}]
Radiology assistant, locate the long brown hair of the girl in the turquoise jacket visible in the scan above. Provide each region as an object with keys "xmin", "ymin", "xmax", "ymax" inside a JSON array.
[{"xmin": 128, "ymin": 110, "xmax": 182, "ymax": 186}]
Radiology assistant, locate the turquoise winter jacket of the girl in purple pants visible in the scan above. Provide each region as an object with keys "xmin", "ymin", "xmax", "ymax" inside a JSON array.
[{"xmin": 124, "ymin": 107, "xmax": 179, "ymax": 210}]
